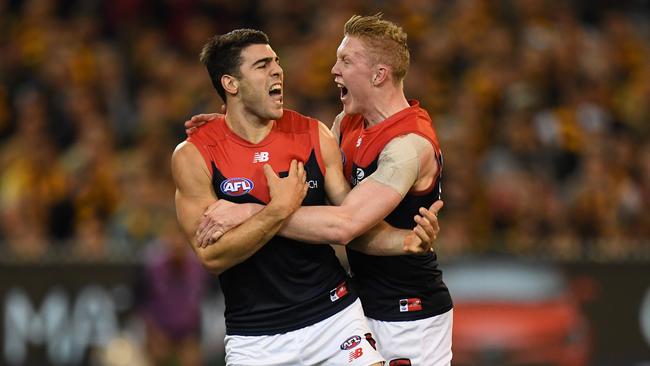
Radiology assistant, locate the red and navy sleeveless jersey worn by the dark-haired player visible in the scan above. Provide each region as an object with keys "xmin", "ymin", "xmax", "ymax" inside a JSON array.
[{"xmin": 188, "ymin": 109, "xmax": 357, "ymax": 335}]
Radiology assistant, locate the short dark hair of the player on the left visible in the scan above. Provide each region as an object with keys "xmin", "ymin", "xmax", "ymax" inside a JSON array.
[{"xmin": 201, "ymin": 29, "xmax": 269, "ymax": 102}]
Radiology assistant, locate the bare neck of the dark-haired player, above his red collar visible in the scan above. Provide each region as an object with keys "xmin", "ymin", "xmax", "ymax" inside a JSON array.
[{"xmin": 226, "ymin": 103, "xmax": 274, "ymax": 144}]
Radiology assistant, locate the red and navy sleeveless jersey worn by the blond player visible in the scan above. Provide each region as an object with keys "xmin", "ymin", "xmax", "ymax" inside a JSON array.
[{"xmin": 340, "ymin": 101, "xmax": 452, "ymax": 321}]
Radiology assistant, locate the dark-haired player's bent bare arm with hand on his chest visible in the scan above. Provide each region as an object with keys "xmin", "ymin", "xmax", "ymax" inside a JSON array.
[{"xmin": 172, "ymin": 142, "xmax": 307, "ymax": 275}]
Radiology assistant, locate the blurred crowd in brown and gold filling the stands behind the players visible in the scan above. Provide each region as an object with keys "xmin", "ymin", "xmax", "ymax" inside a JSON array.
[{"xmin": 0, "ymin": 0, "xmax": 650, "ymax": 260}]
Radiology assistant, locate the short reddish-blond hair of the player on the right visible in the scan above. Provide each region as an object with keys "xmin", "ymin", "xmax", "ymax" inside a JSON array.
[{"xmin": 343, "ymin": 13, "xmax": 410, "ymax": 82}]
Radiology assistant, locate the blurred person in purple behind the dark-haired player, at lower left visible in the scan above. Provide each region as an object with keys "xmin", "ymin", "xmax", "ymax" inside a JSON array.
[{"xmin": 136, "ymin": 219, "xmax": 208, "ymax": 366}]
